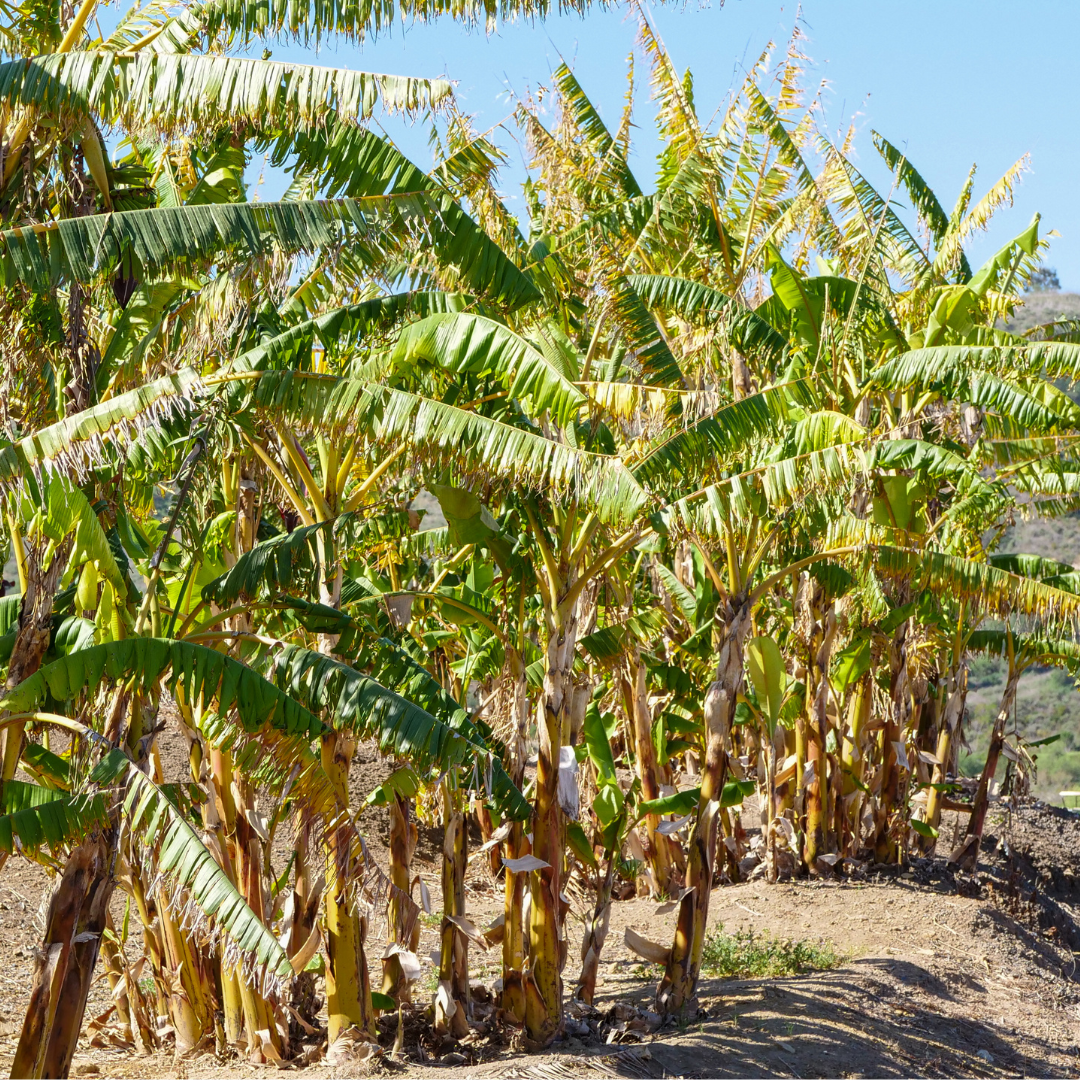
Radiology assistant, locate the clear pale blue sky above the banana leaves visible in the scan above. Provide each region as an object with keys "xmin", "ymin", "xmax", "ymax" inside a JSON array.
[{"xmin": 259, "ymin": 0, "xmax": 1080, "ymax": 292}]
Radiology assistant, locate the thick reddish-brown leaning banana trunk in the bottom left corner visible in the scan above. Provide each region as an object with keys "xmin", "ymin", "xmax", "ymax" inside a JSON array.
[{"xmin": 11, "ymin": 829, "xmax": 116, "ymax": 1077}]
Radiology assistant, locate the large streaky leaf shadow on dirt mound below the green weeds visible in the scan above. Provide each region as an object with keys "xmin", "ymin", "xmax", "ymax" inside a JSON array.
[{"xmin": 501, "ymin": 958, "xmax": 1080, "ymax": 1078}]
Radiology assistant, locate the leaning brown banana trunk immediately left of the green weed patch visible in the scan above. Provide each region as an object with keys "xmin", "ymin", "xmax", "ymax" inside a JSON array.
[{"xmin": 657, "ymin": 596, "xmax": 751, "ymax": 1015}]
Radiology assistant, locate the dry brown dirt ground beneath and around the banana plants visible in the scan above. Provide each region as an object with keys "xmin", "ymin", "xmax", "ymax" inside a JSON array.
[{"xmin": 0, "ymin": 747, "xmax": 1080, "ymax": 1080}]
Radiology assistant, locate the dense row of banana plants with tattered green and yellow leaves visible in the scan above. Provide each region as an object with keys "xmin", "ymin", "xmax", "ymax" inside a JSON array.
[{"xmin": 0, "ymin": 0, "xmax": 1080, "ymax": 1076}]
